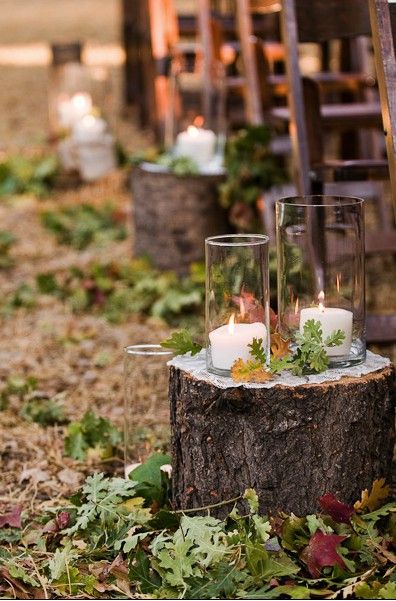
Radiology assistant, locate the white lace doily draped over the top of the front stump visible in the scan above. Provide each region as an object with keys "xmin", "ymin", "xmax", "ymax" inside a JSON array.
[{"xmin": 168, "ymin": 349, "xmax": 390, "ymax": 388}]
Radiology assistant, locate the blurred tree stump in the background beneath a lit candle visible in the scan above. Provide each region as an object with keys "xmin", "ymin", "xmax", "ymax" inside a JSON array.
[{"xmin": 131, "ymin": 167, "xmax": 230, "ymax": 274}]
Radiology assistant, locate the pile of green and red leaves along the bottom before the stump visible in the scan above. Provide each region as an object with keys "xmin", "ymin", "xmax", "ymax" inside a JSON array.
[{"xmin": 0, "ymin": 454, "xmax": 396, "ymax": 599}]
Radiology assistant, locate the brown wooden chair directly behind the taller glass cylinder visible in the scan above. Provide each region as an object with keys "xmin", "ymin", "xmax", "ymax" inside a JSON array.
[{"xmin": 275, "ymin": 0, "xmax": 386, "ymax": 194}]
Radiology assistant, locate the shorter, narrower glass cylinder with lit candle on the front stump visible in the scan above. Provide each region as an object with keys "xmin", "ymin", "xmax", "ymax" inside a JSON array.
[{"xmin": 205, "ymin": 234, "xmax": 270, "ymax": 376}]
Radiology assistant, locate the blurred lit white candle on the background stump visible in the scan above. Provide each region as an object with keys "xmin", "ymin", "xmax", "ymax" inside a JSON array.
[{"xmin": 175, "ymin": 125, "xmax": 216, "ymax": 168}]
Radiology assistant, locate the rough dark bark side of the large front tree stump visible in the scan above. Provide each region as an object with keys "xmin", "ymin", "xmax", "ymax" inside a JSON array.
[{"xmin": 169, "ymin": 367, "xmax": 395, "ymax": 516}]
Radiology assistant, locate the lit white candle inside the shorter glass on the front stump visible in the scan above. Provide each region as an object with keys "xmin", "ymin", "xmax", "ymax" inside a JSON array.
[{"xmin": 209, "ymin": 320, "xmax": 267, "ymax": 370}]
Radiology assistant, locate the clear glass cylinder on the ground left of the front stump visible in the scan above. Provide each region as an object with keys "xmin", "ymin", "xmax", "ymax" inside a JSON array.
[{"xmin": 124, "ymin": 344, "xmax": 173, "ymax": 476}]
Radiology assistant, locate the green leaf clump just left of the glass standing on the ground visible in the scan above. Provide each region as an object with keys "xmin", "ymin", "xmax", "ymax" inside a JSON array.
[{"xmin": 65, "ymin": 411, "xmax": 122, "ymax": 461}]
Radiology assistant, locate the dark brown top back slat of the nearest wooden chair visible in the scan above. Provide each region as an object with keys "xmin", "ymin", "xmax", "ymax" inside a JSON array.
[{"xmin": 295, "ymin": 0, "xmax": 371, "ymax": 43}]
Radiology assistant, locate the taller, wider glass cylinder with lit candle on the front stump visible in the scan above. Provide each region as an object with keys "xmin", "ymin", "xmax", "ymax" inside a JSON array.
[{"xmin": 276, "ymin": 196, "xmax": 366, "ymax": 368}]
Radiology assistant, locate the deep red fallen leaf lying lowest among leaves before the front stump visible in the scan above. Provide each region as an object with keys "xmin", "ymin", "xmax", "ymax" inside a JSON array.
[{"xmin": 301, "ymin": 530, "xmax": 347, "ymax": 578}]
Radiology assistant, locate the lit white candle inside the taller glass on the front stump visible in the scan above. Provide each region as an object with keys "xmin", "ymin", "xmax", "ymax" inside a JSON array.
[{"xmin": 300, "ymin": 292, "xmax": 353, "ymax": 357}]
